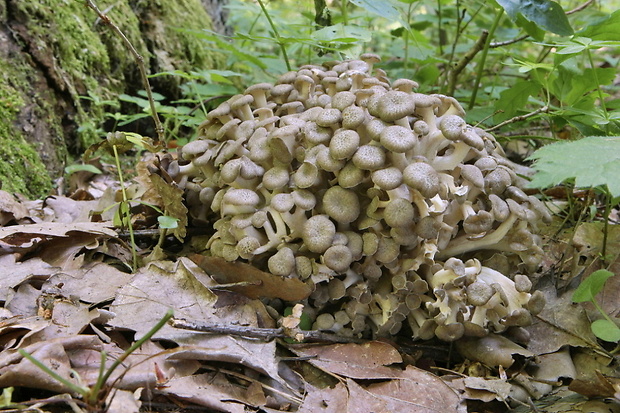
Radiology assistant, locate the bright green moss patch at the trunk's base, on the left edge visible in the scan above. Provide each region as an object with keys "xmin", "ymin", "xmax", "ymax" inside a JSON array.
[{"xmin": 0, "ymin": 82, "xmax": 52, "ymax": 198}]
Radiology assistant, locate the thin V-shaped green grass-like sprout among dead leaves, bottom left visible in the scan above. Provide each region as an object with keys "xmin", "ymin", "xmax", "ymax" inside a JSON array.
[{"xmin": 19, "ymin": 309, "xmax": 173, "ymax": 410}]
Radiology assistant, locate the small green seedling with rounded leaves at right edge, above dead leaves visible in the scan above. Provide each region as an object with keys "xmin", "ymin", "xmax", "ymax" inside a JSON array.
[{"xmin": 573, "ymin": 270, "xmax": 620, "ymax": 343}]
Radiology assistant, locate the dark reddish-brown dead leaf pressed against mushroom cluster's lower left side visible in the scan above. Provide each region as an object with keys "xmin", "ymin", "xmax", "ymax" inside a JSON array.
[{"xmin": 189, "ymin": 254, "xmax": 312, "ymax": 301}]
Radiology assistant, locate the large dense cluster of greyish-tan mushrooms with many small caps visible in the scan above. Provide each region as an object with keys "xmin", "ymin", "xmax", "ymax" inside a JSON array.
[{"xmin": 167, "ymin": 54, "xmax": 549, "ymax": 340}]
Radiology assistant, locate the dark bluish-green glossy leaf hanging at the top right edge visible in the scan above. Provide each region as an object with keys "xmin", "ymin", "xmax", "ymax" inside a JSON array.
[{"xmin": 497, "ymin": 0, "xmax": 573, "ymax": 36}]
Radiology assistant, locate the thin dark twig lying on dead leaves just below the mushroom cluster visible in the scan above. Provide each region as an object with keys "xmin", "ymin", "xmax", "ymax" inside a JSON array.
[{"xmin": 170, "ymin": 318, "xmax": 365, "ymax": 343}]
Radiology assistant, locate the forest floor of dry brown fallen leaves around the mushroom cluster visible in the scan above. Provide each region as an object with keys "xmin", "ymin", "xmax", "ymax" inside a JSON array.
[{"xmin": 0, "ymin": 155, "xmax": 620, "ymax": 413}]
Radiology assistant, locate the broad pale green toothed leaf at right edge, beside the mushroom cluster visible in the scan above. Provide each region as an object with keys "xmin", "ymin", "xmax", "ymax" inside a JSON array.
[{"xmin": 529, "ymin": 136, "xmax": 620, "ymax": 197}]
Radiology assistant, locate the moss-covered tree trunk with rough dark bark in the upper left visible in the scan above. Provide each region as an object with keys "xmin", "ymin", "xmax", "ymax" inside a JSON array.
[{"xmin": 0, "ymin": 0, "xmax": 225, "ymax": 197}]
